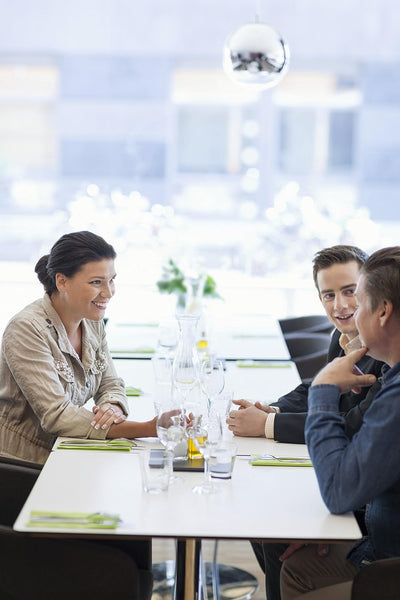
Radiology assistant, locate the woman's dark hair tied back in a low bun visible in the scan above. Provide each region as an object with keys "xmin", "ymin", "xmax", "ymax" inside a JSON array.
[{"xmin": 35, "ymin": 231, "xmax": 117, "ymax": 296}]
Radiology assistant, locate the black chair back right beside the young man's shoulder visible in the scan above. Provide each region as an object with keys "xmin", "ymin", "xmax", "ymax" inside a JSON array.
[{"xmin": 285, "ymin": 333, "xmax": 331, "ymax": 382}]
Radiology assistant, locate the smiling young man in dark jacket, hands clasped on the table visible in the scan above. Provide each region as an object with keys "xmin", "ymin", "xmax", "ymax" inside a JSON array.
[{"xmin": 227, "ymin": 245, "xmax": 383, "ymax": 600}]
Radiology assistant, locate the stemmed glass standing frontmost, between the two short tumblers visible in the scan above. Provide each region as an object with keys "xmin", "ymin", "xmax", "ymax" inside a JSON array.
[{"xmin": 191, "ymin": 415, "xmax": 222, "ymax": 494}]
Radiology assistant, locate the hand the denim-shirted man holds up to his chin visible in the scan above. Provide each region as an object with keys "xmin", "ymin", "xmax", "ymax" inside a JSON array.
[{"xmin": 311, "ymin": 348, "xmax": 376, "ymax": 394}]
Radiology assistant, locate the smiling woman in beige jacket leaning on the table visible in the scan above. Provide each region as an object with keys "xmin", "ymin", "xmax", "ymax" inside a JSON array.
[{"xmin": 0, "ymin": 231, "xmax": 157, "ymax": 463}]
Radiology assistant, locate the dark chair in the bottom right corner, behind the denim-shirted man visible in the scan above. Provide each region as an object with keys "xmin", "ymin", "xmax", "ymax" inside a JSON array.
[{"xmin": 351, "ymin": 557, "xmax": 400, "ymax": 600}]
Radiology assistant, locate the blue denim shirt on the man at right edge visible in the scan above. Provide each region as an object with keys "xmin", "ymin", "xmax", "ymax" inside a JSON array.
[{"xmin": 305, "ymin": 362, "xmax": 400, "ymax": 565}]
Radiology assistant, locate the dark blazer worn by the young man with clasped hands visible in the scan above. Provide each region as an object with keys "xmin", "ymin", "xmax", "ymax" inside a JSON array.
[{"xmin": 271, "ymin": 329, "xmax": 383, "ymax": 444}]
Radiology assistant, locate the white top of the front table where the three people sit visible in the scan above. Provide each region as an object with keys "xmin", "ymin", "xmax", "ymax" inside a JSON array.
[{"xmin": 14, "ymin": 438, "xmax": 361, "ymax": 541}]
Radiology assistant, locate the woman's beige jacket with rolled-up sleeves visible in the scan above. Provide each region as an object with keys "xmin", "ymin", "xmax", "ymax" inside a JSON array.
[{"xmin": 0, "ymin": 294, "xmax": 128, "ymax": 463}]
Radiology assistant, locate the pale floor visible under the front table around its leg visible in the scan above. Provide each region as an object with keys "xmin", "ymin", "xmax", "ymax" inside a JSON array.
[{"xmin": 152, "ymin": 539, "xmax": 266, "ymax": 600}]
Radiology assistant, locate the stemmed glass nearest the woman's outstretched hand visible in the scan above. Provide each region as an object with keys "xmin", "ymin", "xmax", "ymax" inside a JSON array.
[{"xmin": 156, "ymin": 408, "xmax": 186, "ymax": 484}]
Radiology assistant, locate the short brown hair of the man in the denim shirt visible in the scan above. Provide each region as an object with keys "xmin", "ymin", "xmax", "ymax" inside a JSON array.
[{"xmin": 361, "ymin": 246, "xmax": 400, "ymax": 316}]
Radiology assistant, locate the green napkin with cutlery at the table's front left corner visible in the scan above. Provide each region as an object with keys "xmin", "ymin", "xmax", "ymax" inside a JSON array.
[{"xmin": 26, "ymin": 510, "xmax": 121, "ymax": 529}]
